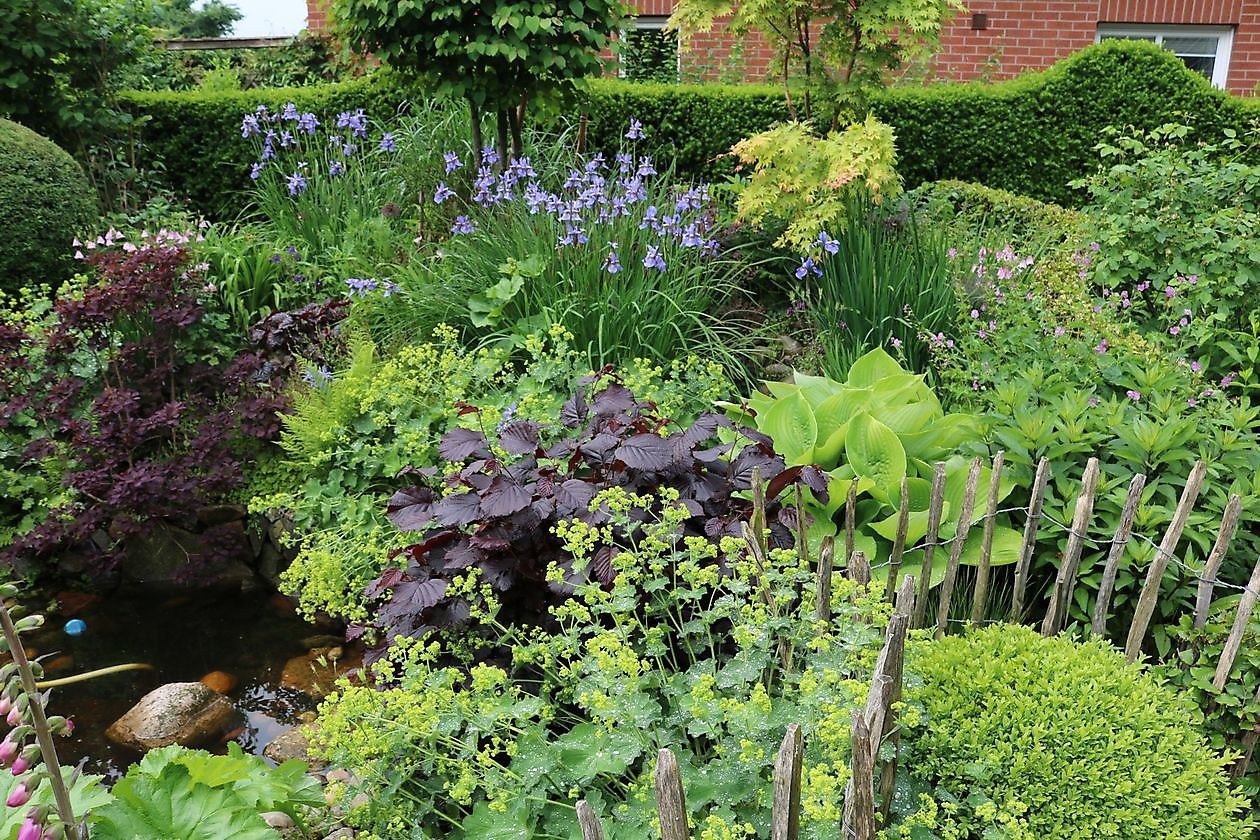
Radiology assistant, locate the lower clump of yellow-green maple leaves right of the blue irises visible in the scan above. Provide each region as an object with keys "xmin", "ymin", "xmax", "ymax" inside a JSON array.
[{"xmin": 732, "ymin": 116, "xmax": 901, "ymax": 252}]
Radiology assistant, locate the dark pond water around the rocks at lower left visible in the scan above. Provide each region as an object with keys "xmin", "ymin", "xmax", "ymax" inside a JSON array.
[{"xmin": 23, "ymin": 592, "xmax": 335, "ymax": 781}]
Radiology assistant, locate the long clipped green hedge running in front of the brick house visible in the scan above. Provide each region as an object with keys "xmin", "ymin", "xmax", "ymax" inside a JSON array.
[{"xmin": 125, "ymin": 40, "xmax": 1260, "ymax": 215}]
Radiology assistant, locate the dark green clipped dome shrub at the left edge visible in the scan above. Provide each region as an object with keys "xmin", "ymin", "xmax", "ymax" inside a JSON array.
[{"xmin": 0, "ymin": 120, "xmax": 97, "ymax": 292}]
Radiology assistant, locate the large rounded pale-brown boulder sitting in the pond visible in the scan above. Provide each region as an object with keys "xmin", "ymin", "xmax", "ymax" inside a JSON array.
[{"xmin": 105, "ymin": 683, "xmax": 239, "ymax": 752}]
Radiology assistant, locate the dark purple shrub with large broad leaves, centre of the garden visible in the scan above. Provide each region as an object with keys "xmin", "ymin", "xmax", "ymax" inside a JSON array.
[{"xmin": 350, "ymin": 370, "xmax": 827, "ymax": 656}]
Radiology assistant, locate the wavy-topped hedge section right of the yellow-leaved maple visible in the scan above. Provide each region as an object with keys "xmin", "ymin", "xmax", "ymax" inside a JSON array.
[{"xmin": 873, "ymin": 40, "xmax": 1260, "ymax": 207}]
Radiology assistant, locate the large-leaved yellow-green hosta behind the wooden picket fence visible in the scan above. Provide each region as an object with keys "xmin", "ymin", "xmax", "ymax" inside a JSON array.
[{"xmin": 730, "ymin": 348, "xmax": 1019, "ymax": 584}]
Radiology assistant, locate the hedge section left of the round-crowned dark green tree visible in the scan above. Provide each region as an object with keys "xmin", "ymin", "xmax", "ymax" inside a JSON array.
[{"xmin": 122, "ymin": 73, "xmax": 415, "ymax": 218}]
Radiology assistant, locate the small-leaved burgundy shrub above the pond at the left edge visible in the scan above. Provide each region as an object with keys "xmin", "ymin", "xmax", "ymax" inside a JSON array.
[{"xmin": 0, "ymin": 246, "xmax": 296, "ymax": 579}]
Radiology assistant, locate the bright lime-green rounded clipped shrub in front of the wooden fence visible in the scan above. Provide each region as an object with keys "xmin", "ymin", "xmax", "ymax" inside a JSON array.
[{"xmin": 903, "ymin": 625, "xmax": 1255, "ymax": 840}]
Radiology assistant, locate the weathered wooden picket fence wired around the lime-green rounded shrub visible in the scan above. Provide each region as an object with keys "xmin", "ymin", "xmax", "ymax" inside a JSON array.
[{"xmin": 577, "ymin": 452, "xmax": 1260, "ymax": 840}]
